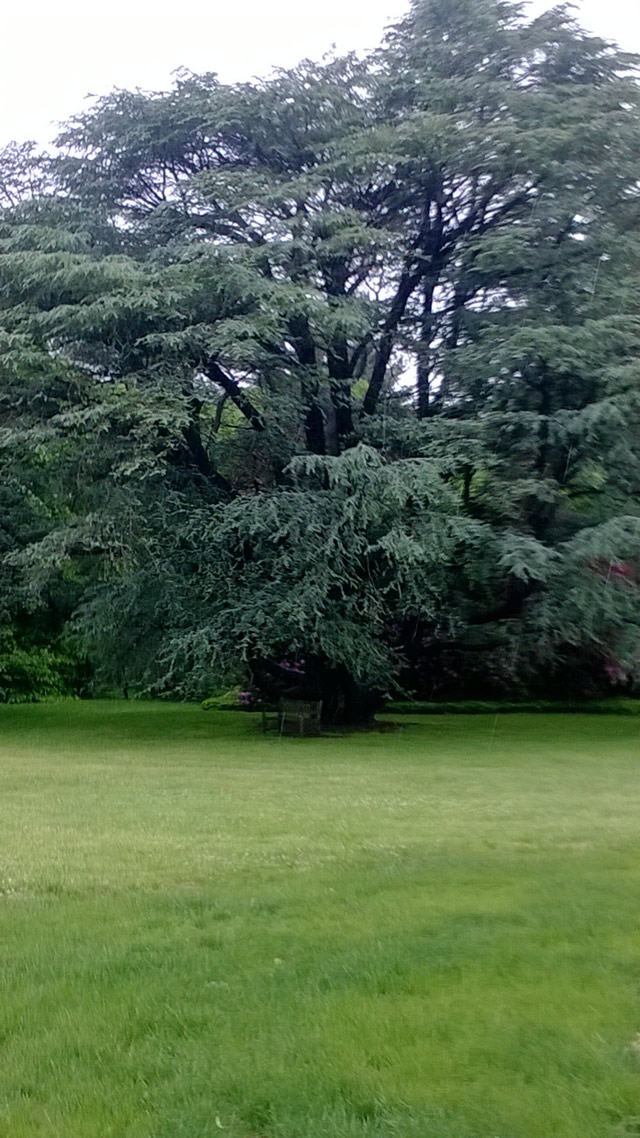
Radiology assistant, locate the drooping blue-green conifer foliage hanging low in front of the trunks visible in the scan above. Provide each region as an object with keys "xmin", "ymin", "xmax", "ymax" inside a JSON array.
[{"xmin": 154, "ymin": 446, "xmax": 477, "ymax": 710}]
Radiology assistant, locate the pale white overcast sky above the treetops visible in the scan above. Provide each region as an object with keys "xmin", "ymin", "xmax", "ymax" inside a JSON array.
[{"xmin": 0, "ymin": 0, "xmax": 640, "ymax": 146}]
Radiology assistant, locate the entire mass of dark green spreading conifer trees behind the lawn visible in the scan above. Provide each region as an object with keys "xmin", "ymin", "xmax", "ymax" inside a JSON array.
[{"xmin": 0, "ymin": 0, "xmax": 640, "ymax": 714}]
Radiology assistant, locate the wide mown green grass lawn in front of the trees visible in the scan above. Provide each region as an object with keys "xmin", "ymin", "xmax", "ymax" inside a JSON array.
[{"xmin": 0, "ymin": 703, "xmax": 640, "ymax": 1138}]
